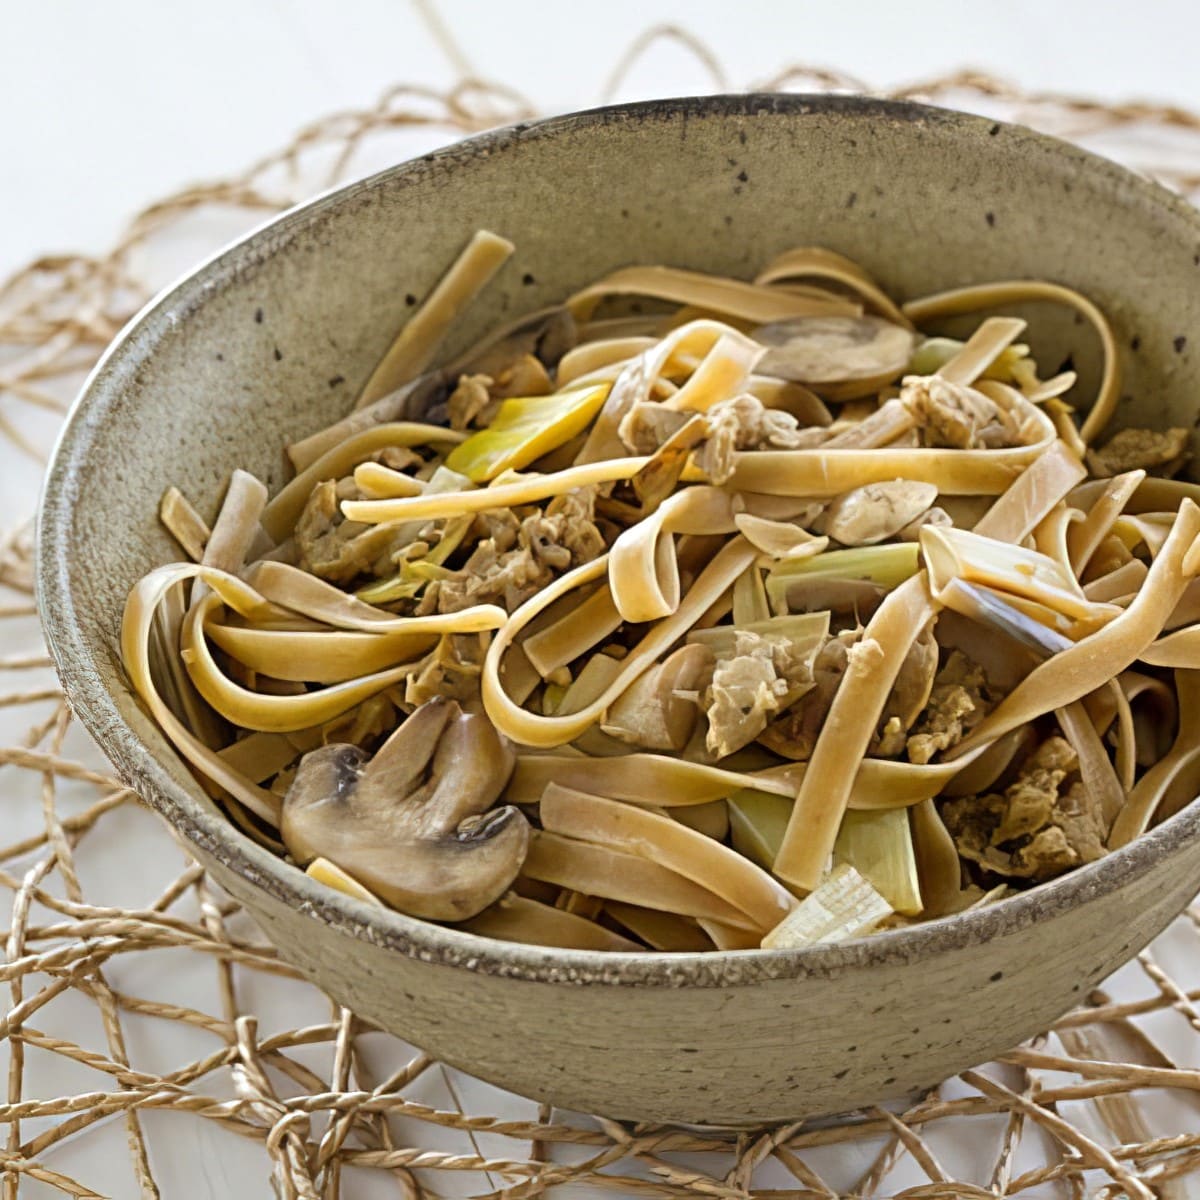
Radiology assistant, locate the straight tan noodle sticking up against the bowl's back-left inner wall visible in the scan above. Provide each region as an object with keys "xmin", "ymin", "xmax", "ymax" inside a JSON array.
[{"xmin": 355, "ymin": 229, "xmax": 516, "ymax": 408}]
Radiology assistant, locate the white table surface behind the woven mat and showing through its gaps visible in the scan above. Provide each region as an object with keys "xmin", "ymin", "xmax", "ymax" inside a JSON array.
[{"xmin": 7, "ymin": 0, "xmax": 1200, "ymax": 1200}]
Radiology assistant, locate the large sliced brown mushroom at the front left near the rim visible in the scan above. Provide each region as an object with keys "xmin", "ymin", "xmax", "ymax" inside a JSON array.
[{"xmin": 280, "ymin": 696, "xmax": 529, "ymax": 920}]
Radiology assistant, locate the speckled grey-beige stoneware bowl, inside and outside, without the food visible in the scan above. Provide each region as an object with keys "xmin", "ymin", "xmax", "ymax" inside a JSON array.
[{"xmin": 38, "ymin": 96, "xmax": 1200, "ymax": 1124}]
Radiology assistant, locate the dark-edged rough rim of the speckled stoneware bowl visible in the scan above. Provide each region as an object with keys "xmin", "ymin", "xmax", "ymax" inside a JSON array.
[{"xmin": 36, "ymin": 92, "xmax": 1200, "ymax": 988}]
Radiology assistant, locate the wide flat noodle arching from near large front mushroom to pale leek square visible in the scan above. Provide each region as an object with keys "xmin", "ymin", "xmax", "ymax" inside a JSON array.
[{"xmin": 540, "ymin": 784, "xmax": 796, "ymax": 931}]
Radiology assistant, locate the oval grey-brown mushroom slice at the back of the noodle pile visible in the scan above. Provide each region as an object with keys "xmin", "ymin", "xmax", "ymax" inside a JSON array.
[{"xmin": 751, "ymin": 317, "xmax": 914, "ymax": 400}]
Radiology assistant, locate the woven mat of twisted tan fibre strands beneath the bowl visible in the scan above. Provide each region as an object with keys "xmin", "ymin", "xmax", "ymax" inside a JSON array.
[{"xmin": 7, "ymin": 29, "xmax": 1200, "ymax": 1200}]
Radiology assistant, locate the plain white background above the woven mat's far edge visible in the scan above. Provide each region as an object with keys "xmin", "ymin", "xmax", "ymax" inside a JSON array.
[{"xmin": 0, "ymin": 0, "xmax": 1200, "ymax": 274}]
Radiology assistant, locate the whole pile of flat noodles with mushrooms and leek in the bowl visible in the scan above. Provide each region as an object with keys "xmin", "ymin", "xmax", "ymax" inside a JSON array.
[{"xmin": 122, "ymin": 233, "xmax": 1200, "ymax": 950}]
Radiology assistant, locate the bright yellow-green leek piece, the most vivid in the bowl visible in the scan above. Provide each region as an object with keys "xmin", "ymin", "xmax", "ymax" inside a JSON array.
[{"xmin": 446, "ymin": 383, "xmax": 610, "ymax": 484}]
